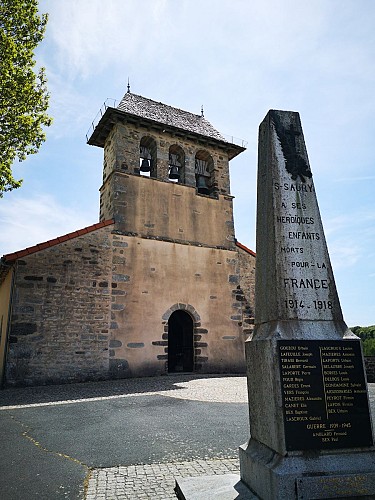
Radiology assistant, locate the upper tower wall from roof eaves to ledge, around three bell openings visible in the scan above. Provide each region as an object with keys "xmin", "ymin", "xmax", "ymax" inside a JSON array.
[{"xmin": 100, "ymin": 123, "xmax": 234, "ymax": 242}]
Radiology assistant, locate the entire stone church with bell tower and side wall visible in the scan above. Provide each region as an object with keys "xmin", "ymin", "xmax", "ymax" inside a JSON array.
[{"xmin": 0, "ymin": 88, "xmax": 255, "ymax": 385}]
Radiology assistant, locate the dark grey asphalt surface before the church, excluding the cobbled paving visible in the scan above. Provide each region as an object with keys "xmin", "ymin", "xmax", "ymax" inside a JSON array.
[{"xmin": 0, "ymin": 376, "xmax": 249, "ymax": 500}]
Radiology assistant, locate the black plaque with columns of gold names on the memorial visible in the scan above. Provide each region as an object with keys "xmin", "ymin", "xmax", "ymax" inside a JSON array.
[{"xmin": 277, "ymin": 340, "xmax": 373, "ymax": 451}]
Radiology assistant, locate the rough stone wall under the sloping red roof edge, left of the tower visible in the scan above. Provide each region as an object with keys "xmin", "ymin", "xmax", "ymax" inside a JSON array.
[{"xmin": 6, "ymin": 226, "xmax": 112, "ymax": 385}]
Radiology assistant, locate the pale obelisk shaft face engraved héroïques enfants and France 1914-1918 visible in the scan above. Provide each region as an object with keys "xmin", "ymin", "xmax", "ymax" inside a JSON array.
[{"xmin": 273, "ymin": 173, "xmax": 339, "ymax": 320}]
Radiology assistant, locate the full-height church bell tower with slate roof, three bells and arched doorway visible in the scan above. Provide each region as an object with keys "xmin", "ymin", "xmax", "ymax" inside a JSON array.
[{"xmin": 88, "ymin": 91, "xmax": 254, "ymax": 378}]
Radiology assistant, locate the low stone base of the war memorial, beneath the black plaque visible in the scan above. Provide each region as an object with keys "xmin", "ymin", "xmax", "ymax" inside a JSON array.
[{"xmin": 239, "ymin": 439, "xmax": 375, "ymax": 500}]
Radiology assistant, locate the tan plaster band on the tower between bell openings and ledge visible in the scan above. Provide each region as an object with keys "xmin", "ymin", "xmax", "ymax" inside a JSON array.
[{"xmin": 102, "ymin": 173, "xmax": 234, "ymax": 249}]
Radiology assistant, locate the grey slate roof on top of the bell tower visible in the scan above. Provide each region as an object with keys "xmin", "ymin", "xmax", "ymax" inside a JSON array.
[{"xmin": 117, "ymin": 92, "xmax": 227, "ymax": 142}]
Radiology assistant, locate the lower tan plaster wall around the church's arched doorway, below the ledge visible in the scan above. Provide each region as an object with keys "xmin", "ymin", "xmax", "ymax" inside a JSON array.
[{"xmin": 110, "ymin": 235, "xmax": 244, "ymax": 376}]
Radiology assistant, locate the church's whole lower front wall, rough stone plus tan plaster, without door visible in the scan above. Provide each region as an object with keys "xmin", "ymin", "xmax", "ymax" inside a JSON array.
[{"xmin": 2, "ymin": 226, "xmax": 254, "ymax": 385}]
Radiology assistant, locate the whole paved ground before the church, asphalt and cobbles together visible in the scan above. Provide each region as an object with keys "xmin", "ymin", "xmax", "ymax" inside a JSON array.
[{"xmin": 0, "ymin": 375, "xmax": 375, "ymax": 500}]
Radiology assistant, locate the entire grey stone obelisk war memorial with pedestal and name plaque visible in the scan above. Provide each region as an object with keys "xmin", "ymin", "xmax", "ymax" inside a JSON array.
[{"xmin": 240, "ymin": 110, "xmax": 375, "ymax": 500}]
